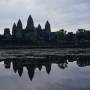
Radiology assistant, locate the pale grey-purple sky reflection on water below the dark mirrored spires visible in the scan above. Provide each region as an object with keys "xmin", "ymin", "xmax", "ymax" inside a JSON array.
[{"xmin": 0, "ymin": 62, "xmax": 90, "ymax": 90}]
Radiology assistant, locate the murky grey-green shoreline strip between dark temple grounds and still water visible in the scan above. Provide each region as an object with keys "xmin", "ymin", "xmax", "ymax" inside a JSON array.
[{"xmin": 0, "ymin": 48, "xmax": 90, "ymax": 59}]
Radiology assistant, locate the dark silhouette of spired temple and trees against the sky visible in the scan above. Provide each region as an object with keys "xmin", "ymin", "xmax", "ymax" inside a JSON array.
[{"xmin": 0, "ymin": 15, "xmax": 90, "ymax": 48}]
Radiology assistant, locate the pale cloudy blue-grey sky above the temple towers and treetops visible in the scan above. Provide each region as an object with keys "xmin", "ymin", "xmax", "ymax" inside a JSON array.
[{"xmin": 0, "ymin": 0, "xmax": 90, "ymax": 33}]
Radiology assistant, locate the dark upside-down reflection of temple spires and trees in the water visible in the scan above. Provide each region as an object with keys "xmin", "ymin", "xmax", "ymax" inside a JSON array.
[{"xmin": 1, "ymin": 56, "xmax": 90, "ymax": 81}]
